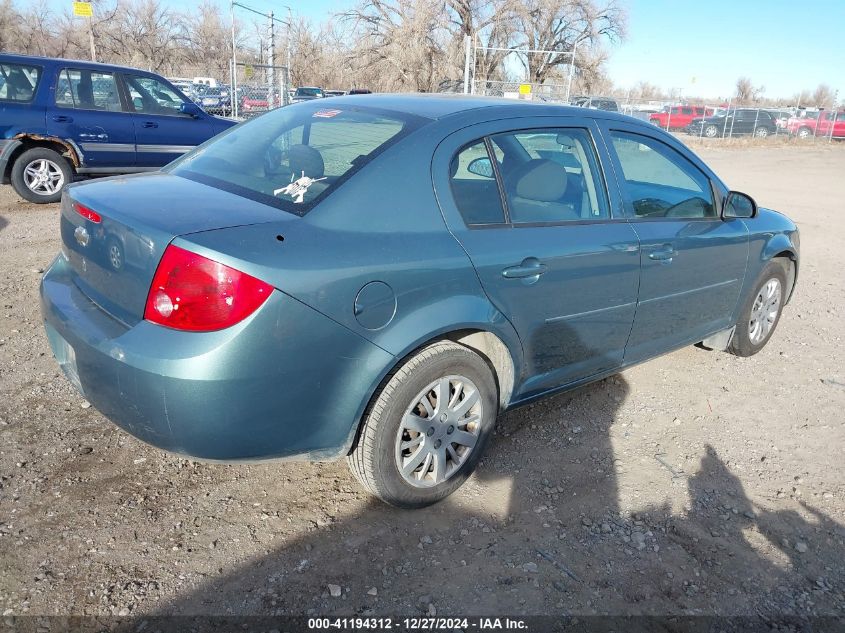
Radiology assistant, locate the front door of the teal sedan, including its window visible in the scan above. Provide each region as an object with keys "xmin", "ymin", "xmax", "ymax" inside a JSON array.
[{"xmin": 605, "ymin": 123, "xmax": 748, "ymax": 363}]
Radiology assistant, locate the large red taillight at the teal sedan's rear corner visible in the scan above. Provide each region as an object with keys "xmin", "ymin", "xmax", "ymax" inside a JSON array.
[{"xmin": 144, "ymin": 244, "xmax": 273, "ymax": 332}]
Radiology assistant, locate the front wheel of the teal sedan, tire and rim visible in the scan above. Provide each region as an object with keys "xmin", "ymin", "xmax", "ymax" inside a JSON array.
[{"xmin": 728, "ymin": 259, "xmax": 788, "ymax": 357}]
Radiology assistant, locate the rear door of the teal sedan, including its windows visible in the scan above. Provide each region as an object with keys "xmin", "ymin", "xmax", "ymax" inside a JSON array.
[{"xmin": 433, "ymin": 118, "xmax": 639, "ymax": 397}]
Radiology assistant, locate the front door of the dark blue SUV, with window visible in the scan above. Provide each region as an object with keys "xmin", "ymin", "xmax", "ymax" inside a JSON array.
[{"xmin": 122, "ymin": 73, "xmax": 214, "ymax": 167}]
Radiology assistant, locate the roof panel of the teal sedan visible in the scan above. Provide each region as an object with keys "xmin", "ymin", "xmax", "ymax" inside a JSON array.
[{"xmin": 320, "ymin": 93, "xmax": 631, "ymax": 121}]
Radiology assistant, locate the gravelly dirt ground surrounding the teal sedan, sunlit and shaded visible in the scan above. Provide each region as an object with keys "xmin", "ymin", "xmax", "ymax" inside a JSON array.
[{"xmin": 0, "ymin": 144, "xmax": 845, "ymax": 616}]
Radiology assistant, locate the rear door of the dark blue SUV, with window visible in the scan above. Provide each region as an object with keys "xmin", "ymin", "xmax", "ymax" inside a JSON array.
[{"xmin": 46, "ymin": 68, "xmax": 135, "ymax": 171}]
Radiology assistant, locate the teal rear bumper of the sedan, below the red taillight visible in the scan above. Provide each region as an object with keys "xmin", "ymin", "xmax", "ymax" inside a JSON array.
[{"xmin": 41, "ymin": 255, "xmax": 393, "ymax": 461}]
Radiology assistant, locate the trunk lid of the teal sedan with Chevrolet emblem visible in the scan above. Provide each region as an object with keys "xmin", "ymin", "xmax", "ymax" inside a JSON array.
[{"xmin": 61, "ymin": 173, "xmax": 290, "ymax": 326}]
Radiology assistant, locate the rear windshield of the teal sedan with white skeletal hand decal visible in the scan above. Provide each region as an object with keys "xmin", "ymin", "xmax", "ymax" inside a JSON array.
[{"xmin": 164, "ymin": 102, "xmax": 425, "ymax": 215}]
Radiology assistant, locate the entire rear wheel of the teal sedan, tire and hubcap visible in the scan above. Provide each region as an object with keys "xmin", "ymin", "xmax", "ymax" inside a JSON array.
[{"xmin": 347, "ymin": 341, "xmax": 499, "ymax": 508}]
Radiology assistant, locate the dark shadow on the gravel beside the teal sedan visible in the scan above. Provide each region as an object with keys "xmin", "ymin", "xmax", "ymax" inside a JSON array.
[{"xmin": 120, "ymin": 375, "xmax": 845, "ymax": 617}]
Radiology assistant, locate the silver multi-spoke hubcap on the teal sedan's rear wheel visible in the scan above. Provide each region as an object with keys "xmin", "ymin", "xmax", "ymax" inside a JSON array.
[{"xmin": 395, "ymin": 376, "xmax": 482, "ymax": 488}]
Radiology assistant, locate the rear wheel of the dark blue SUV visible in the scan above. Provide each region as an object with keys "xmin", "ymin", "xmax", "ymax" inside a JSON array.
[{"xmin": 11, "ymin": 147, "xmax": 73, "ymax": 204}]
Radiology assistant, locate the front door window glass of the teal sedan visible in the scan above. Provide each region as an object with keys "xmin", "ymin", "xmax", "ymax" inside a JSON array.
[{"xmin": 611, "ymin": 131, "xmax": 716, "ymax": 218}]
